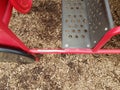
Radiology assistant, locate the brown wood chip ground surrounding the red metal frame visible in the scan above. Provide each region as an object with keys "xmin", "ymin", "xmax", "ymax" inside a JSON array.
[{"xmin": 0, "ymin": 0, "xmax": 120, "ymax": 90}]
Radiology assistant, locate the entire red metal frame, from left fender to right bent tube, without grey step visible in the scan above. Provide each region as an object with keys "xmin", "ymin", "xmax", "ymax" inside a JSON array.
[{"xmin": 0, "ymin": 0, "xmax": 120, "ymax": 61}]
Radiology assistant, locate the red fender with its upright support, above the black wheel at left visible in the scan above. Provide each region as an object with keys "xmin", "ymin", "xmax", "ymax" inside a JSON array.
[{"xmin": 0, "ymin": 0, "xmax": 33, "ymax": 55}]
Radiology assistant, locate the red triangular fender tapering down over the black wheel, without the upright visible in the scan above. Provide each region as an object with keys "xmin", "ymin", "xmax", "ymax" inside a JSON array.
[{"xmin": 0, "ymin": 23, "xmax": 29, "ymax": 52}]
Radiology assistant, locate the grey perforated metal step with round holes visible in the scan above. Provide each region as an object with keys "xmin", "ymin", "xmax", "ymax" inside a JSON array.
[{"xmin": 62, "ymin": 0, "xmax": 113, "ymax": 48}]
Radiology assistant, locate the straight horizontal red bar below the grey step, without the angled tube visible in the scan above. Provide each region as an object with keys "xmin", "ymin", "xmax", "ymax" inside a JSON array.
[{"xmin": 30, "ymin": 49, "xmax": 120, "ymax": 54}]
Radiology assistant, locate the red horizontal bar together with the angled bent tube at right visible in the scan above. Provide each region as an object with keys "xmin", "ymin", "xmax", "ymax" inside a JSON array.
[{"xmin": 30, "ymin": 27, "xmax": 120, "ymax": 54}]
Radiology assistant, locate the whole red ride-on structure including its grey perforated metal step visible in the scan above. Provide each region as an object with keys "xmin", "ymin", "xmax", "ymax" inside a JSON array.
[{"xmin": 0, "ymin": 0, "xmax": 120, "ymax": 60}]
